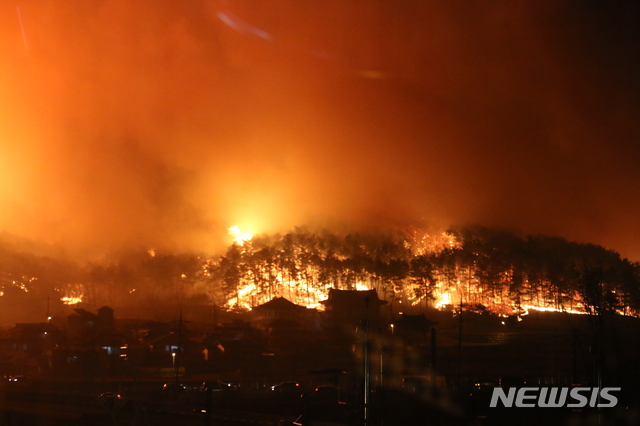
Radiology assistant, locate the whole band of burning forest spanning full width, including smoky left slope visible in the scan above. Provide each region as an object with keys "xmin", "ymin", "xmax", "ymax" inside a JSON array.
[{"xmin": 0, "ymin": 226, "xmax": 640, "ymax": 322}]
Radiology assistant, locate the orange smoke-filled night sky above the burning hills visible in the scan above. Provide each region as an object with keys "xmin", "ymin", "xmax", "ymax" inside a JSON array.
[{"xmin": 0, "ymin": 0, "xmax": 640, "ymax": 260}]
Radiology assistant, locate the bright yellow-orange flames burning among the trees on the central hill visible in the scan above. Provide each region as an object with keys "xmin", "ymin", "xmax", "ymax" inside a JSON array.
[{"xmin": 212, "ymin": 230, "xmax": 636, "ymax": 318}]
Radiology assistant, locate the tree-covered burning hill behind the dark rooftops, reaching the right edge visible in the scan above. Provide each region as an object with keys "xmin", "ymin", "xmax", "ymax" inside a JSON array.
[{"xmin": 207, "ymin": 227, "xmax": 640, "ymax": 316}]
